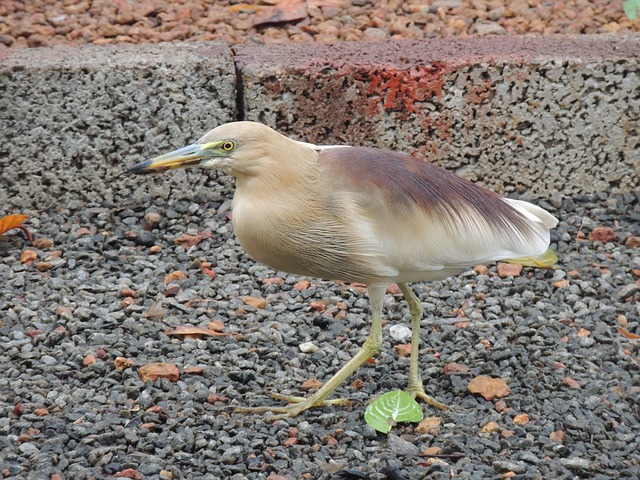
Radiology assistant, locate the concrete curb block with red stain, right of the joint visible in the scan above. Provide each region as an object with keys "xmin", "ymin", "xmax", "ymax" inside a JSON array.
[{"xmin": 235, "ymin": 36, "xmax": 640, "ymax": 197}]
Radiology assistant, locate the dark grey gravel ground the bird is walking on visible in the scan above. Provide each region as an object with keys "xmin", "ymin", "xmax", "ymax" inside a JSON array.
[{"xmin": 0, "ymin": 183, "xmax": 640, "ymax": 480}]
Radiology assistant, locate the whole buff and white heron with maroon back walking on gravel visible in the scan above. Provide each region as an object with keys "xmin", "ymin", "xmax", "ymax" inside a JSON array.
[{"xmin": 124, "ymin": 121, "xmax": 558, "ymax": 418}]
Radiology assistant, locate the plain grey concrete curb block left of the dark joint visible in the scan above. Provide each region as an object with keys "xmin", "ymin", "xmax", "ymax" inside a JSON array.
[{"xmin": 0, "ymin": 44, "xmax": 235, "ymax": 209}]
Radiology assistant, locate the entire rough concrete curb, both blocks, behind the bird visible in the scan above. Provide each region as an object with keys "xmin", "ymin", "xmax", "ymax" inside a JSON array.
[{"xmin": 0, "ymin": 35, "xmax": 640, "ymax": 209}]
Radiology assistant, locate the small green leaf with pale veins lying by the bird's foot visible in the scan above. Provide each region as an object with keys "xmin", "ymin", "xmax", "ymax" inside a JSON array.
[{"xmin": 364, "ymin": 390, "xmax": 424, "ymax": 433}]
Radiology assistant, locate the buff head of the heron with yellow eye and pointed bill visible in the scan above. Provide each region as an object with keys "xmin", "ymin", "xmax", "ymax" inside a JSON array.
[{"xmin": 125, "ymin": 122, "xmax": 302, "ymax": 176}]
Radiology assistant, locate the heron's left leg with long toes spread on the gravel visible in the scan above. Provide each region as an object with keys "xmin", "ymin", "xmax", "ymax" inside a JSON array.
[{"xmin": 235, "ymin": 286, "xmax": 385, "ymax": 420}]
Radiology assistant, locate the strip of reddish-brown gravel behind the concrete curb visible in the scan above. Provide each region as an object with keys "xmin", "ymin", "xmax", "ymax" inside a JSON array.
[{"xmin": 0, "ymin": 0, "xmax": 640, "ymax": 47}]
